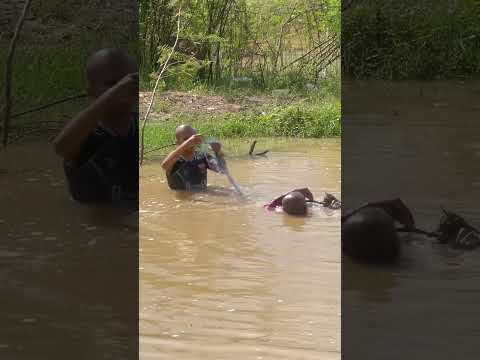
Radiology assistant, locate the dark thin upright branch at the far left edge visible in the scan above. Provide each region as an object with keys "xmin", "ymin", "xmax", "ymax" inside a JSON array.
[{"xmin": 3, "ymin": 0, "xmax": 32, "ymax": 147}]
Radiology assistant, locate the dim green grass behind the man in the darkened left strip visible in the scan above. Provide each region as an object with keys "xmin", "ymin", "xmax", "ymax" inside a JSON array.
[{"xmin": 0, "ymin": 35, "xmax": 136, "ymax": 126}]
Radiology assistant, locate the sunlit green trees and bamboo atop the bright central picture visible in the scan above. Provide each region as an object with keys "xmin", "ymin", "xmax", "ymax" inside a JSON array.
[{"xmin": 140, "ymin": 0, "xmax": 340, "ymax": 89}]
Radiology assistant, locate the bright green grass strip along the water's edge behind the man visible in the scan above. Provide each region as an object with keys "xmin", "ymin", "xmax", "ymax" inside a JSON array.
[{"xmin": 145, "ymin": 98, "xmax": 341, "ymax": 150}]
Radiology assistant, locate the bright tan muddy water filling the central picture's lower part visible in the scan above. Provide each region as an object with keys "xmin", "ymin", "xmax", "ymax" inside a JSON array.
[{"xmin": 140, "ymin": 140, "xmax": 340, "ymax": 360}]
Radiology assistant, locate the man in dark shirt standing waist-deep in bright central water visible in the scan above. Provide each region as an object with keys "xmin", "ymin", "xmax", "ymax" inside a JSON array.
[{"xmin": 162, "ymin": 125, "xmax": 223, "ymax": 191}]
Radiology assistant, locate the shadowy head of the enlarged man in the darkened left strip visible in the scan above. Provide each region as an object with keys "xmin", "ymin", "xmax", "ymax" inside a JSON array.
[{"xmin": 87, "ymin": 48, "xmax": 138, "ymax": 98}]
